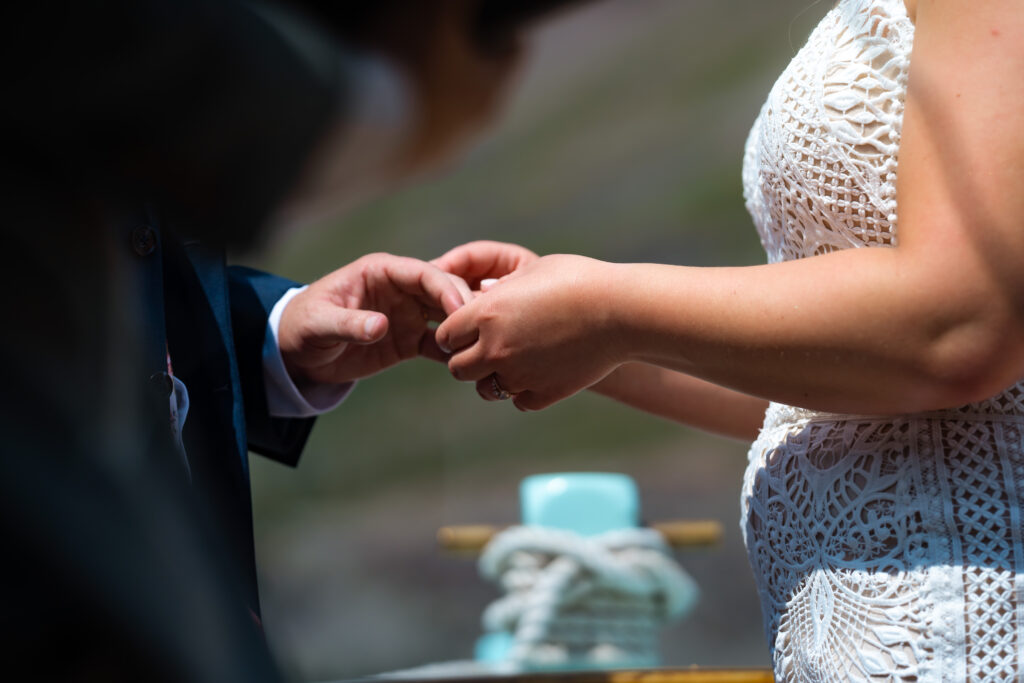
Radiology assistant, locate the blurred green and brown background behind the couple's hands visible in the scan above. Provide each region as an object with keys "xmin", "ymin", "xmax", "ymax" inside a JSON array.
[{"xmin": 239, "ymin": 0, "xmax": 830, "ymax": 680}]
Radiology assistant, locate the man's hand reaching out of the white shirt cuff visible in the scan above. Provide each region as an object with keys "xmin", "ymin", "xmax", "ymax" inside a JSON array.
[{"xmin": 278, "ymin": 254, "xmax": 472, "ymax": 386}]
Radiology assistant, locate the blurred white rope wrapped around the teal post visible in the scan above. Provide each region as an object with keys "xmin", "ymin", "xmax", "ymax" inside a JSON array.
[{"xmin": 479, "ymin": 526, "xmax": 697, "ymax": 670}]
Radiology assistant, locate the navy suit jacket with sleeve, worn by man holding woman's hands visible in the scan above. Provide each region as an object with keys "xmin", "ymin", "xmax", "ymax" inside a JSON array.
[{"xmin": 136, "ymin": 220, "xmax": 313, "ymax": 615}]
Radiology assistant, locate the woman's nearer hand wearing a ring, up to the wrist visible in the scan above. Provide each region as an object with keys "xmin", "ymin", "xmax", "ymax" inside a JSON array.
[{"xmin": 436, "ymin": 255, "xmax": 625, "ymax": 411}]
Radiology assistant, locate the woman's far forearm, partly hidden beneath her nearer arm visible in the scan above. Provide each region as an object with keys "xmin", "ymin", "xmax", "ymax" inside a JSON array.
[{"xmin": 590, "ymin": 362, "xmax": 768, "ymax": 441}]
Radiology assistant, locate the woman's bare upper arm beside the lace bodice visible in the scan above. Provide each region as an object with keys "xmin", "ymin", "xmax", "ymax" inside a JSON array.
[{"xmin": 897, "ymin": 0, "xmax": 1024, "ymax": 358}]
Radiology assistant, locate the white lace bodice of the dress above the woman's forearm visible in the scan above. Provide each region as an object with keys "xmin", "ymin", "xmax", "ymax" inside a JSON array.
[{"xmin": 743, "ymin": 0, "xmax": 913, "ymax": 261}]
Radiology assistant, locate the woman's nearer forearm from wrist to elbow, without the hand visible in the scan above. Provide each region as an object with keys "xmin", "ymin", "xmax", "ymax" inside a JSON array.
[{"xmin": 605, "ymin": 248, "xmax": 1024, "ymax": 413}]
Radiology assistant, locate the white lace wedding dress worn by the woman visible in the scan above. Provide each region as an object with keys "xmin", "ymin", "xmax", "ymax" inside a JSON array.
[{"xmin": 742, "ymin": 0, "xmax": 1024, "ymax": 682}]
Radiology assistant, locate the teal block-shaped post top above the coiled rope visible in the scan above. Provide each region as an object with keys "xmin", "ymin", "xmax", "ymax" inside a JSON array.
[{"xmin": 519, "ymin": 472, "xmax": 640, "ymax": 536}]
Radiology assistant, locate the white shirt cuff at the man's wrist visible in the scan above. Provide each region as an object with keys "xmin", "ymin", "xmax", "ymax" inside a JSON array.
[{"xmin": 263, "ymin": 287, "xmax": 355, "ymax": 418}]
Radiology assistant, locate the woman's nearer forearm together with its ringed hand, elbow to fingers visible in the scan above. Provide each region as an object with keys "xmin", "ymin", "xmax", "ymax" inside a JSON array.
[{"xmin": 436, "ymin": 240, "xmax": 1024, "ymax": 414}]
